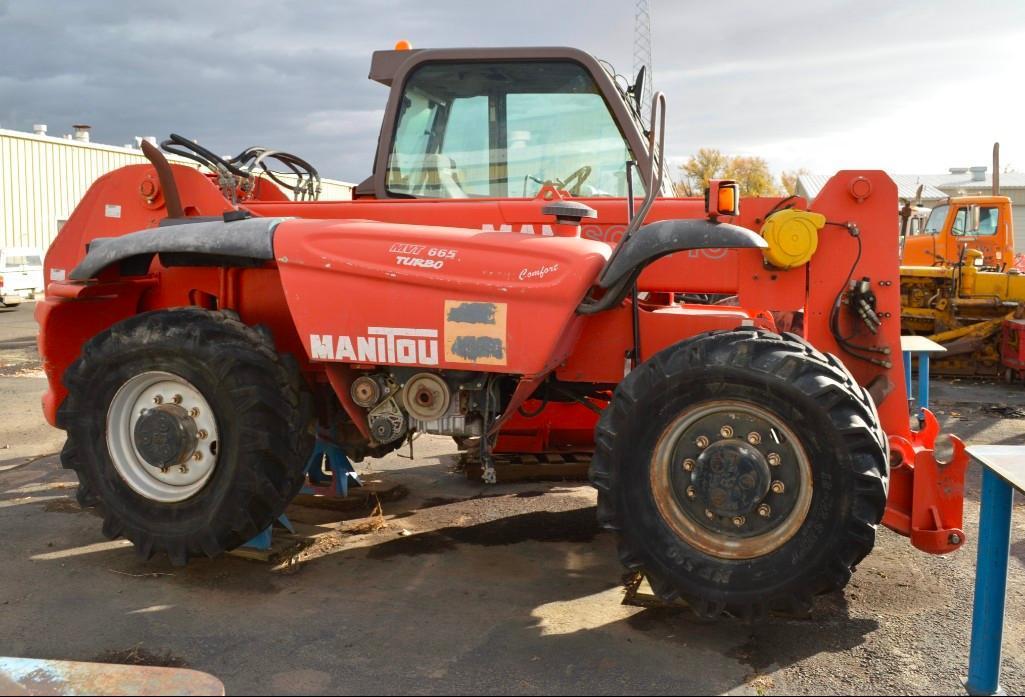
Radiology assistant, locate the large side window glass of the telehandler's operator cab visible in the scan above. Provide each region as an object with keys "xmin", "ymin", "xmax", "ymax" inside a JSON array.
[{"xmin": 387, "ymin": 62, "xmax": 644, "ymax": 199}]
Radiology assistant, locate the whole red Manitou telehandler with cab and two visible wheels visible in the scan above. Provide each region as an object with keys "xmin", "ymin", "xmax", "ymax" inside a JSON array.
[{"xmin": 37, "ymin": 48, "xmax": 967, "ymax": 617}]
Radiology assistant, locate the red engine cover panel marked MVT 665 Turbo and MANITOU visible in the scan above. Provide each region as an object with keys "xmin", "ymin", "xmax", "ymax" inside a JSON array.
[{"xmin": 275, "ymin": 220, "xmax": 609, "ymax": 375}]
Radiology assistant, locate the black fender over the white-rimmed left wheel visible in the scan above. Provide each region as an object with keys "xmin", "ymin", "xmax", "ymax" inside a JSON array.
[{"xmin": 69, "ymin": 217, "xmax": 285, "ymax": 281}]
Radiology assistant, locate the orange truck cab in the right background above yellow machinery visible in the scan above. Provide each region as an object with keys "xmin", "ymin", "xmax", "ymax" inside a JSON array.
[{"xmin": 901, "ymin": 196, "xmax": 1015, "ymax": 270}]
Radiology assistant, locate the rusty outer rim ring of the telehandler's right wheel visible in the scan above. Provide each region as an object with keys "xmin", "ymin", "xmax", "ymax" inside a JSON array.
[{"xmin": 649, "ymin": 400, "xmax": 813, "ymax": 560}]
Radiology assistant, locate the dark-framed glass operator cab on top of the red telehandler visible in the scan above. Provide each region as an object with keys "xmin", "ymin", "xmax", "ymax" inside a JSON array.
[{"xmin": 357, "ymin": 48, "xmax": 650, "ymax": 199}]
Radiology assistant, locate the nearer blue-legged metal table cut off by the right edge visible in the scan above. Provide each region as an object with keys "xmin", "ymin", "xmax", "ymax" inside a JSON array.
[{"xmin": 965, "ymin": 445, "xmax": 1025, "ymax": 695}]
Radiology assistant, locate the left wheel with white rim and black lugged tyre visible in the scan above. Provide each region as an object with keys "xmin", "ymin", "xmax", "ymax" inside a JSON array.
[{"xmin": 58, "ymin": 308, "xmax": 314, "ymax": 565}]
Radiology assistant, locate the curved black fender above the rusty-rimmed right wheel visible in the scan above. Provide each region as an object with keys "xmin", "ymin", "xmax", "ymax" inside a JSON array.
[{"xmin": 577, "ymin": 218, "xmax": 769, "ymax": 315}]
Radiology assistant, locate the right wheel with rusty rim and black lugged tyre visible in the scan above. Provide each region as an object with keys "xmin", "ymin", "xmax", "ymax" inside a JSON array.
[{"xmin": 590, "ymin": 328, "xmax": 889, "ymax": 619}]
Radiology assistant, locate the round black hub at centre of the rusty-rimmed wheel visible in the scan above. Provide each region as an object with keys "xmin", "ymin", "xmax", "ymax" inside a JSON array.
[{"xmin": 691, "ymin": 439, "xmax": 772, "ymax": 518}]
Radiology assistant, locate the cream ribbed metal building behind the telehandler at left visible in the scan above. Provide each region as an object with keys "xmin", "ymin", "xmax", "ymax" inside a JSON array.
[{"xmin": 0, "ymin": 126, "xmax": 353, "ymax": 252}]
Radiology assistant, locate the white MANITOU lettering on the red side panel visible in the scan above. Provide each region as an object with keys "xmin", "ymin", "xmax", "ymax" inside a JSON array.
[{"xmin": 310, "ymin": 327, "xmax": 438, "ymax": 366}]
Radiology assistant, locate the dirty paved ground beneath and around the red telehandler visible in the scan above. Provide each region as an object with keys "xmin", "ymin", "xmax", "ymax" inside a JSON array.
[{"xmin": 0, "ymin": 303, "xmax": 1025, "ymax": 694}]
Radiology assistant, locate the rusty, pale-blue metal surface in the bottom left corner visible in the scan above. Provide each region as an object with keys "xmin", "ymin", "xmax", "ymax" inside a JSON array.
[{"xmin": 0, "ymin": 657, "xmax": 224, "ymax": 695}]
